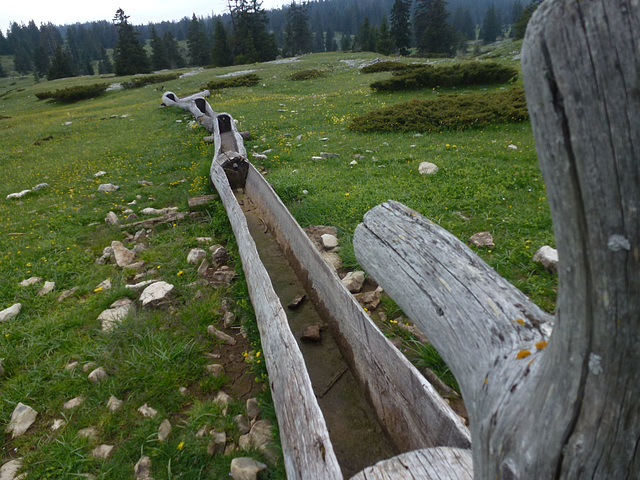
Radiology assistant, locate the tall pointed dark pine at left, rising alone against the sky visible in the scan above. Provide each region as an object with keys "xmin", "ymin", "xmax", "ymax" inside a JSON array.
[{"xmin": 113, "ymin": 8, "xmax": 151, "ymax": 76}]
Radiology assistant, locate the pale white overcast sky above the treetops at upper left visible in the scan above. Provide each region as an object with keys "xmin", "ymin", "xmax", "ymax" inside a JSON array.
[{"xmin": 0, "ymin": 0, "xmax": 291, "ymax": 35}]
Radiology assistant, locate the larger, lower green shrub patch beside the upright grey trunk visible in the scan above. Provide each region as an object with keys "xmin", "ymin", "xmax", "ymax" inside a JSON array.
[{"xmin": 349, "ymin": 88, "xmax": 529, "ymax": 132}]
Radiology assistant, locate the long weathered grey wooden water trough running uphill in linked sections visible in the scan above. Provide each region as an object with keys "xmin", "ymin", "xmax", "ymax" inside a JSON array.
[{"xmin": 163, "ymin": 92, "xmax": 472, "ymax": 480}]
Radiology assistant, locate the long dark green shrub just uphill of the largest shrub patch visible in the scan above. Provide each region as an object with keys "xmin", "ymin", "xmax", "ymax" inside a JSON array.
[{"xmin": 371, "ymin": 62, "xmax": 518, "ymax": 92}]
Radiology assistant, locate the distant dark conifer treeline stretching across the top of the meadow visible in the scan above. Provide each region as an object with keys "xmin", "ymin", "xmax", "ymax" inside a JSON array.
[{"xmin": 0, "ymin": 0, "xmax": 539, "ymax": 78}]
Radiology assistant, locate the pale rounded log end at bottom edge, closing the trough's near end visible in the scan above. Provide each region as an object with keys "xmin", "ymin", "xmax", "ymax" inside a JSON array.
[{"xmin": 351, "ymin": 447, "xmax": 473, "ymax": 480}]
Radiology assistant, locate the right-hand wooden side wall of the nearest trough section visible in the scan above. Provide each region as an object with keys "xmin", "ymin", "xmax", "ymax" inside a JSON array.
[{"xmin": 245, "ymin": 166, "xmax": 470, "ymax": 451}]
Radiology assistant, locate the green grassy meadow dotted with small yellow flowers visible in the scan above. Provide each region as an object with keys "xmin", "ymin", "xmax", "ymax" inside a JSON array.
[{"xmin": 0, "ymin": 41, "xmax": 557, "ymax": 480}]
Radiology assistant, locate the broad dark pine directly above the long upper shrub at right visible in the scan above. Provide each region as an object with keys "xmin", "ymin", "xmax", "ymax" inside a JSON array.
[{"xmin": 414, "ymin": 0, "xmax": 455, "ymax": 56}]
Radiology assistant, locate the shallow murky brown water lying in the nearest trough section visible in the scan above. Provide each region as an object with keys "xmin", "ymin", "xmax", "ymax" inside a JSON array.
[{"xmin": 244, "ymin": 198, "xmax": 395, "ymax": 478}]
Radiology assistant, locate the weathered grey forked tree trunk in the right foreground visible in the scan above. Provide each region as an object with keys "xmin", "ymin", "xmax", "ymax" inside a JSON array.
[{"xmin": 354, "ymin": 0, "xmax": 640, "ymax": 480}]
